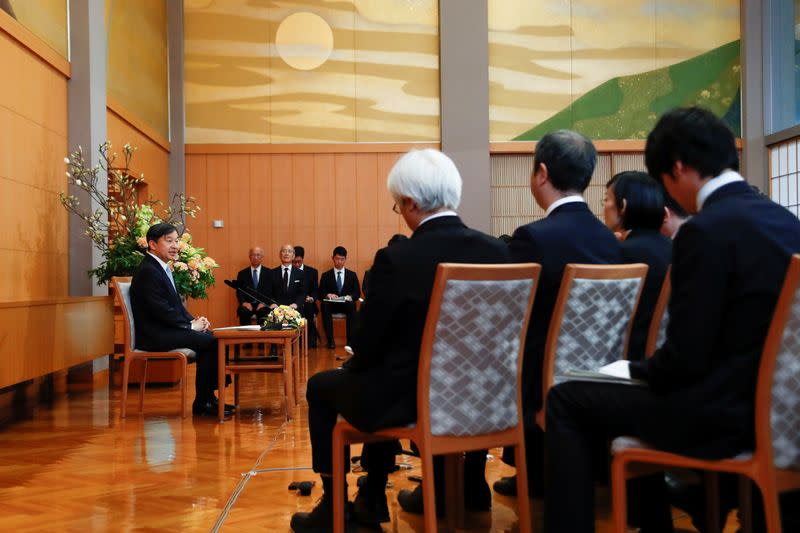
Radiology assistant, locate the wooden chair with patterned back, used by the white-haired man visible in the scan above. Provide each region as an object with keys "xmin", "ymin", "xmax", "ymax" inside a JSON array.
[{"xmin": 333, "ymin": 263, "xmax": 541, "ymax": 533}]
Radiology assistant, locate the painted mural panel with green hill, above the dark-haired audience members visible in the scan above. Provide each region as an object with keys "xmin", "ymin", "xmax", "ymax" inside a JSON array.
[{"xmin": 489, "ymin": 0, "xmax": 741, "ymax": 141}]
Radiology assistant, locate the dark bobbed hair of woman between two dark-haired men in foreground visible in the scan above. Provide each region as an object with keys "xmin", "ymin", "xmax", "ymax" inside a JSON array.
[{"xmin": 606, "ymin": 170, "xmax": 664, "ymax": 230}]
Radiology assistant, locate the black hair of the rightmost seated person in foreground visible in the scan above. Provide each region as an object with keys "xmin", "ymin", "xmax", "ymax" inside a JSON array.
[{"xmin": 644, "ymin": 107, "xmax": 739, "ymax": 183}]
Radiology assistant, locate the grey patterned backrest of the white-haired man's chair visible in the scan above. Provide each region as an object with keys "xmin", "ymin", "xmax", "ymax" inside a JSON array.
[{"xmin": 417, "ymin": 263, "xmax": 541, "ymax": 437}]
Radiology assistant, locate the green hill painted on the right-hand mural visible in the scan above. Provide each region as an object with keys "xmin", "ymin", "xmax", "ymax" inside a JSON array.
[{"xmin": 514, "ymin": 40, "xmax": 742, "ymax": 141}]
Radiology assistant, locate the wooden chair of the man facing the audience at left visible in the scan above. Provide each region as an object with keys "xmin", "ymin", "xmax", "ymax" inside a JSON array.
[{"xmin": 111, "ymin": 276, "xmax": 196, "ymax": 418}]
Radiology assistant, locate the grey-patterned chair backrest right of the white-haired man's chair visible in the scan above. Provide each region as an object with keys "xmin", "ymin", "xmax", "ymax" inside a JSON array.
[{"xmin": 542, "ymin": 263, "xmax": 647, "ymax": 392}]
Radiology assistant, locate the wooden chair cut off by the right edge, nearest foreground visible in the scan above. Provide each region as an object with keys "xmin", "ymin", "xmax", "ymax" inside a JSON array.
[{"xmin": 611, "ymin": 255, "xmax": 800, "ymax": 533}]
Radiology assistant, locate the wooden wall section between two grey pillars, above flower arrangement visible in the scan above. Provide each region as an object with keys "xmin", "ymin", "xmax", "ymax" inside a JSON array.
[{"xmin": 106, "ymin": 107, "xmax": 171, "ymax": 205}]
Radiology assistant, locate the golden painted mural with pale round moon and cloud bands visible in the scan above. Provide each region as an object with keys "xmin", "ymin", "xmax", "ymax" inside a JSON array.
[{"xmin": 184, "ymin": 0, "xmax": 439, "ymax": 143}]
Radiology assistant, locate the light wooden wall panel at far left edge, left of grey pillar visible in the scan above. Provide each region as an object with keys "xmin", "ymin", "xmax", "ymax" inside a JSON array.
[{"xmin": 0, "ymin": 25, "xmax": 69, "ymax": 302}]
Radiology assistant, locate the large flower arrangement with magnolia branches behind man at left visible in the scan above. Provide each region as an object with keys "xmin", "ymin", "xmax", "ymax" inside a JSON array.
[{"xmin": 60, "ymin": 142, "xmax": 219, "ymax": 298}]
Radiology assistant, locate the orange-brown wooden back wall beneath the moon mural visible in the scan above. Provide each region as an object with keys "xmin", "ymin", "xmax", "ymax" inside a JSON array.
[{"xmin": 186, "ymin": 145, "xmax": 410, "ymax": 325}]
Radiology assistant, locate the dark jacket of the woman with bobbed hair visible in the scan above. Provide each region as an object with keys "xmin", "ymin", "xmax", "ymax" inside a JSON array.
[{"xmin": 619, "ymin": 229, "xmax": 672, "ymax": 361}]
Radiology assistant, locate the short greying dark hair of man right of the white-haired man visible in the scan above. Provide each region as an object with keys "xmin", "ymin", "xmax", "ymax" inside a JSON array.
[{"xmin": 533, "ymin": 130, "xmax": 597, "ymax": 193}]
